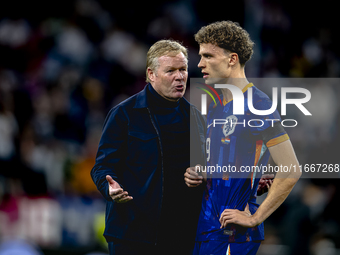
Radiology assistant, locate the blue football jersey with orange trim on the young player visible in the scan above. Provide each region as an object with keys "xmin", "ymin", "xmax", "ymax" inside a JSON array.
[{"xmin": 196, "ymin": 83, "xmax": 289, "ymax": 242}]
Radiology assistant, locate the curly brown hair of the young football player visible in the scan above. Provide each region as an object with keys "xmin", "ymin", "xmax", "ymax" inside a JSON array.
[{"xmin": 195, "ymin": 20, "xmax": 254, "ymax": 66}]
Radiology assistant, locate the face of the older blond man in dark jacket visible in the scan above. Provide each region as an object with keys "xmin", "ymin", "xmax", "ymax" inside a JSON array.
[{"xmin": 148, "ymin": 52, "xmax": 188, "ymax": 102}]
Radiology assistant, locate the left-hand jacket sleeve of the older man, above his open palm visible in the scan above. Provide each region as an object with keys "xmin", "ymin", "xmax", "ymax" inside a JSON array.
[{"xmin": 91, "ymin": 107, "xmax": 128, "ymax": 201}]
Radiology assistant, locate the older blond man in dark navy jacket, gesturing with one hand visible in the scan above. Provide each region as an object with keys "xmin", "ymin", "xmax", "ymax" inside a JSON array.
[{"xmin": 91, "ymin": 40, "xmax": 206, "ymax": 254}]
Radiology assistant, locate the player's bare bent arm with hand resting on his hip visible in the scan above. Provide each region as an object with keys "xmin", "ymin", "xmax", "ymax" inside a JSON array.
[{"xmin": 220, "ymin": 140, "xmax": 301, "ymax": 228}]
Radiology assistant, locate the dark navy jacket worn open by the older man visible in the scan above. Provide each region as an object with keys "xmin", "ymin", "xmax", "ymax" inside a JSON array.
[{"xmin": 91, "ymin": 84, "xmax": 206, "ymax": 243}]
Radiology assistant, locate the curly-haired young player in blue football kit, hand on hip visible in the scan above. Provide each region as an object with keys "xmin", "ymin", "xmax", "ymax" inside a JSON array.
[{"xmin": 185, "ymin": 21, "xmax": 301, "ymax": 255}]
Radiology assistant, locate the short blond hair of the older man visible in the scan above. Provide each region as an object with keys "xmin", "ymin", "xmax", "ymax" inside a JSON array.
[{"xmin": 146, "ymin": 40, "xmax": 188, "ymax": 82}]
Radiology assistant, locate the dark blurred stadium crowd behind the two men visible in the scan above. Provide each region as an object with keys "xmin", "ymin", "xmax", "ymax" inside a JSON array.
[{"xmin": 0, "ymin": 0, "xmax": 340, "ymax": 255}]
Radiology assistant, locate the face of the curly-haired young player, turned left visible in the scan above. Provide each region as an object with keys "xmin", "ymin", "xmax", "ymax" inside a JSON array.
[{"xmin": 198, "ymin": 43, "xmax": 230, "ymax": 85}]
